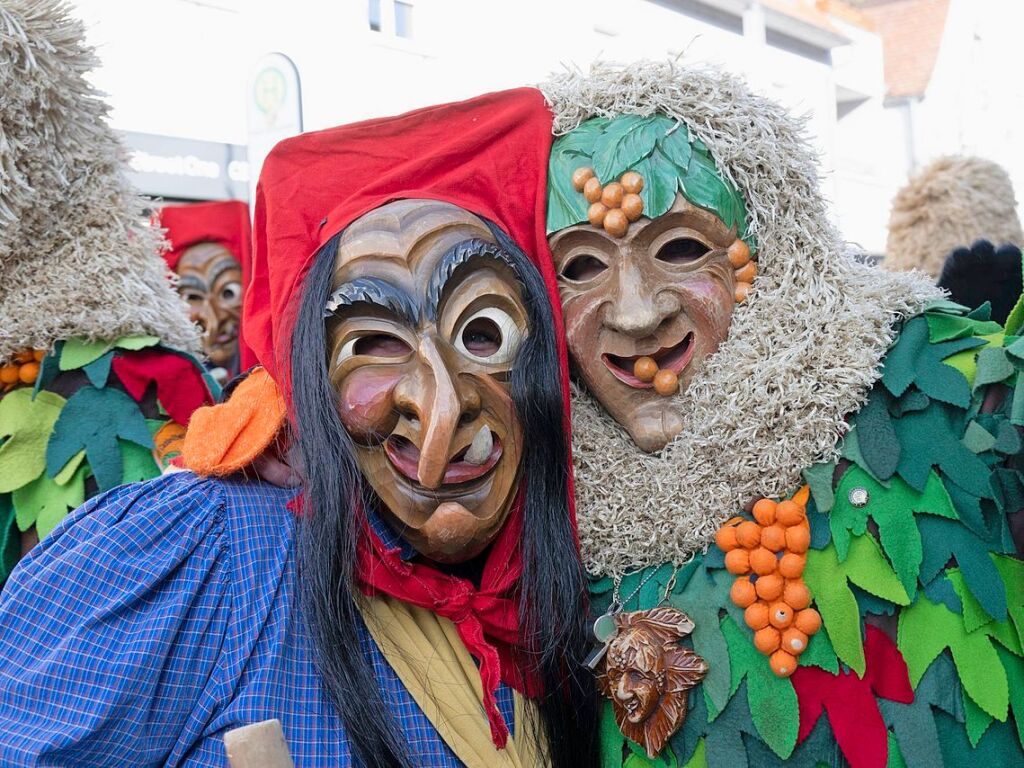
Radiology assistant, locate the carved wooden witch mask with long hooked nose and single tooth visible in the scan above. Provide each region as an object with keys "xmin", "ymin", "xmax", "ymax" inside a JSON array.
[{"xmin": 327, "ymin": 200, "xmax": 527, "ymax": 563}]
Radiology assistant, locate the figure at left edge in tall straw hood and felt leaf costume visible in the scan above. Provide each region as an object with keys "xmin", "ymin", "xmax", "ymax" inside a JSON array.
[{"xmin": 0, "ymin": 0, "xmax": 216, "ymax": 582}]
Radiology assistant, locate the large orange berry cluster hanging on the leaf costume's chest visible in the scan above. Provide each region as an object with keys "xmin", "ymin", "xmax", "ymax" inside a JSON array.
[{"xmin": 715, "ymin": 494, "xmax": 821, "ymax": 677}]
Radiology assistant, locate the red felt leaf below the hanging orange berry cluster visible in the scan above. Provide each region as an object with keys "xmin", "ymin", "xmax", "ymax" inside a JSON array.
[{"xmin": 792, "ymin": 626, "xmax": 913, "ymax": 768}]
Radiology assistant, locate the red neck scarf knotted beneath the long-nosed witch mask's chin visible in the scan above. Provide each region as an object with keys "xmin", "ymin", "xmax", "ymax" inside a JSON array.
[{"xmin": 356, "ymin": 497, "xmax": 538, "ymax": 749}]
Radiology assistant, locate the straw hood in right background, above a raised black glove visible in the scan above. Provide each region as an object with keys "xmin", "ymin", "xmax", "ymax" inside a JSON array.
[{"xmin": 883, "ymin": 156, "xmax": 1024, "ymax": 278}]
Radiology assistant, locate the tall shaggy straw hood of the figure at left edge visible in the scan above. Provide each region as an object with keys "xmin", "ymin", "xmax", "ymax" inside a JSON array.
[{"xmin": 0, "ymin": 0, "xmax": 200, "ymax": 361}]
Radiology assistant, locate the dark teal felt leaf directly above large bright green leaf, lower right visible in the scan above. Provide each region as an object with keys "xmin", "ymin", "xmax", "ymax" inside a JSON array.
[{"xmin": 918, "ymin": 517, "xmax": 1007, "ymax": 622}]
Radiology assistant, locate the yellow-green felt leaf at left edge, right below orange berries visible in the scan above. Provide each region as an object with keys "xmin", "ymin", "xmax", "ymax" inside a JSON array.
[{"xmin": 0, "ymin": 388, "xmax": 65, "ymax": 494}]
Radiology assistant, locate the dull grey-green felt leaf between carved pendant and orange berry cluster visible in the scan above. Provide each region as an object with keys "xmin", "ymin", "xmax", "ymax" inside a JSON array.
[{"xmin": 669, "ymin": 567, "xmax": 732, "ymax": 712}]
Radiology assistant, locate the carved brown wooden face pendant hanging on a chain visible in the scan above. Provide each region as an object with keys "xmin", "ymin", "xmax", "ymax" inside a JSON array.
[{"xmin": 597, "ymin": 606, "xmax": 708, "ymax": 758}]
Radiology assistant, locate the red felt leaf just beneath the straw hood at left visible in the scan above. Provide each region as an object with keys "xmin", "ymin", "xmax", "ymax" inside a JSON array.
[{"xmin": 114, "ymin": 349, "xmax": 213, "ymax": 427}]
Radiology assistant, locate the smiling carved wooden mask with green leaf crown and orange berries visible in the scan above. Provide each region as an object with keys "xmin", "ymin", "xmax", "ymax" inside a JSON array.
[{"xmin": 548, "ymin": 115, "xmax": 757, "ymax": 452}]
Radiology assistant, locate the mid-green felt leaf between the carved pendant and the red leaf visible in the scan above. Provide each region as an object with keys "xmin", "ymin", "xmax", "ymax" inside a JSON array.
[{"xmin": 722, "ymin": 616, "xmax": 800, "ymax": 758}]
